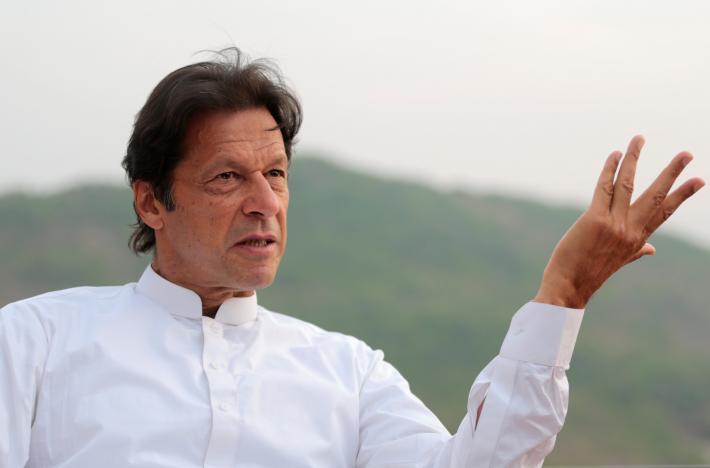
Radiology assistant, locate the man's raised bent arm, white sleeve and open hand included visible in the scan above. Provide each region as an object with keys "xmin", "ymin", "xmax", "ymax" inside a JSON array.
[{"xmin": 357, "ymin": 136, "xmax": 704, "ymax": 467}]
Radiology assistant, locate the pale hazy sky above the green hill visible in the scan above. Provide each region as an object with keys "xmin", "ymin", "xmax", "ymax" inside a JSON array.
[{"xmin": 0, "ymin": 0, "xmax": 710, "ymax": 248}]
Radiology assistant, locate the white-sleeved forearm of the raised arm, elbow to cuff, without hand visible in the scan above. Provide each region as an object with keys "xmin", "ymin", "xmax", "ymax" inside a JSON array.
[{"xmin": 468, "ymin": 302, "xmax": 583, "ymax": 467}]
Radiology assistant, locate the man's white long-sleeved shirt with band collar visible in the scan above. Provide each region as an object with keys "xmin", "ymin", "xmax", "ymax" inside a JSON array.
[{"xmin": 0, "ymin": 267, "xmax": 582, "ymax": 468}]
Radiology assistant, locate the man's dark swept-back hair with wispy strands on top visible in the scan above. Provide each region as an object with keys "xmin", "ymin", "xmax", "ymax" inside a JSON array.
[{"xmin": 122, "ymin": 47, "xmax": 303, "ymax": 254}]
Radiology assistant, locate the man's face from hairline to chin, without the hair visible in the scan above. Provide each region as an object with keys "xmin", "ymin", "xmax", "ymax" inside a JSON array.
[{"xmin": 156, "ymin": 108, "xmax": 289, "ymax": 292}]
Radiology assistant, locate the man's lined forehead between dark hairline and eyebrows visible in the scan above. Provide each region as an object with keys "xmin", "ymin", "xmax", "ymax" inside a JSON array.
[{"xmin": 182, "ymin": 108, "xmax": 286, "ymax": 166}]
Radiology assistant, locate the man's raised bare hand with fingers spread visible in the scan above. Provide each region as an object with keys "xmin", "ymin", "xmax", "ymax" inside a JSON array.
[{"xmin": 533, "ymin": 135, "xmax": 705, "ymax": 309}]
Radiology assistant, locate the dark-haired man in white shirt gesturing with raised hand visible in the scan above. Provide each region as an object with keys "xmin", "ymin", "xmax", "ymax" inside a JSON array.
[{"xmin": 0, "ymin": 51, "xmax": 704, "ymax": 468}]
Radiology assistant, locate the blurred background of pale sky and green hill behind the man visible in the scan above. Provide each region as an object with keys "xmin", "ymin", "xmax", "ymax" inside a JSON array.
[{"xmin": 0, "ymin": 0, "xmax": 710, "ymax": 465}]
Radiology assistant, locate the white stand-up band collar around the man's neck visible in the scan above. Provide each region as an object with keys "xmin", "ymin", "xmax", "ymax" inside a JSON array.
[{"xmin": 136, "ymin": 265, "xmax": 257, "ymax": 325}]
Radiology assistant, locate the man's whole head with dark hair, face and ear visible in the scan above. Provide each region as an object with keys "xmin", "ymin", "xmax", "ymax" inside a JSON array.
[{"xmin": 123, "ymin": 49, "xmax": 302, "ymax": 300}]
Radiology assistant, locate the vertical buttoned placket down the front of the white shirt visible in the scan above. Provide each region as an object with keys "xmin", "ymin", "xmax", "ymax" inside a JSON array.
[{"xmin": 202, "ymin": 317, "xmax": 239, "ymax": 468}]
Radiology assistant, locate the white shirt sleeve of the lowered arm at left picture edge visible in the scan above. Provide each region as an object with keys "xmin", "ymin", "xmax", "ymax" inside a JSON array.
[{"xmin": 0, "ymin": 303, "xmax": 48, "ymax": 468}]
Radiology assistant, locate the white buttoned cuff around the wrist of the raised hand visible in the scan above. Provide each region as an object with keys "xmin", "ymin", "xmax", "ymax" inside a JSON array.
[{"xmin": 500, "ymin": 302, "xmax": 584, "ymax": 369}]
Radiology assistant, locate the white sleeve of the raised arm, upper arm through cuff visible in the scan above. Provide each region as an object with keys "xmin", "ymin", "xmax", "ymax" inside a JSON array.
[{"xmin": 357, "ymin": 302, "xmax": 583, "ymax": 468}]
